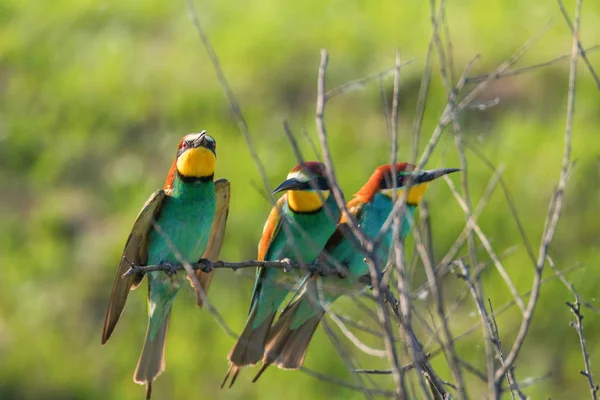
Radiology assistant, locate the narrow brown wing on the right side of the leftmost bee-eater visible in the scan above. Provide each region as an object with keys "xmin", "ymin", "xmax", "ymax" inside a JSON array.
[{"xmin": 188, "ymin": 178, "xmax": 230, "ymax": 307}]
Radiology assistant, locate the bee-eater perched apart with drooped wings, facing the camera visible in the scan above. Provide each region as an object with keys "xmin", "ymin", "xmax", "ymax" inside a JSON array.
[{"xmin": 102, "ymin": 131, "xmax": 229, "ymax": 399}]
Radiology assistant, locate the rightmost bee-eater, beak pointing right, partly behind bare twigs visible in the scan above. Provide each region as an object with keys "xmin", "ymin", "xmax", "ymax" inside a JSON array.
[{"xmin": 253, "ymin": 163, "xmax": 458, "ymax": 382}]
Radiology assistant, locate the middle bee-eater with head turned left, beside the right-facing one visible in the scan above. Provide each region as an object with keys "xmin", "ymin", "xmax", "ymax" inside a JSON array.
[{"xmin": 221, "ymin": 161, "xmax": 339, "ymax": 387}]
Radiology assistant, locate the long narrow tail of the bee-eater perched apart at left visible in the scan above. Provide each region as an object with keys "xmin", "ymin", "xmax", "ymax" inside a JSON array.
[{"xmin": 133, "ymin": 304, "xmax": 171, "ymax": 400}]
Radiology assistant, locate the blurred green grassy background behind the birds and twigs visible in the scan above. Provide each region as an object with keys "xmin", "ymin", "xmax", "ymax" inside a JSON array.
[{"xmin": 0, "ymin": 0, "xmax": 600, "ymax": 400}]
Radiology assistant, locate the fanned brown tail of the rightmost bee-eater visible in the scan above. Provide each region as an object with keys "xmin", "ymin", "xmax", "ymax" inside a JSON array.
[{"xmin": 252, "ymin": 293, "xmax": 325, "ymax": 382}]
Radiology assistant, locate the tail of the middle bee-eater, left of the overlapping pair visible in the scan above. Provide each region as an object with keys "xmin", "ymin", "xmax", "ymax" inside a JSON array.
[{"xmin": 221, "ymin": 307, "xmax": 276, "ymax": 388}]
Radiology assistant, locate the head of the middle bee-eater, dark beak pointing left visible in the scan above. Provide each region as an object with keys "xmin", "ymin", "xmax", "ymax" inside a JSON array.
[{"xmin": 273, "ymin": 161, "xmax": 330, "ymax": 213}]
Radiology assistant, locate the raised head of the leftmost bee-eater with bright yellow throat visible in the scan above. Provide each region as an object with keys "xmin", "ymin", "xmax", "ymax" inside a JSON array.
[{"xmin": 164, "ymin": 131, "xmax": 217, "ymax": 189}]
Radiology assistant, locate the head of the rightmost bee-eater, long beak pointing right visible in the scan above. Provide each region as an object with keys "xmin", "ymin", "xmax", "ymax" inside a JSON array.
[{"xmin": 355, "ymin": 163, "xmax": 460, "ymax": 205}]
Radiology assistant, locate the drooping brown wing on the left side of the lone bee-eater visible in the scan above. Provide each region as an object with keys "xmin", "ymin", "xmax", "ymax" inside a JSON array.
[{"xmin": 102, "ymin": 189, "xmax": 166, "ymax": 344}]
